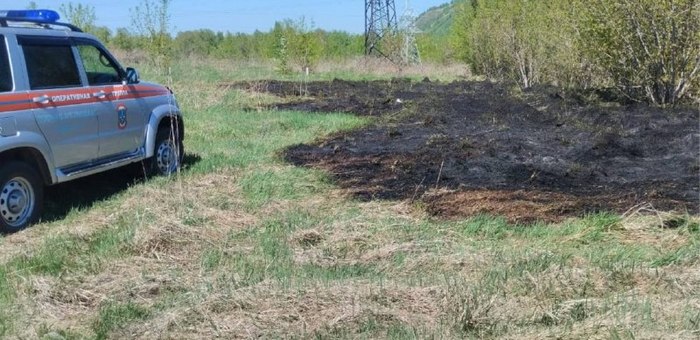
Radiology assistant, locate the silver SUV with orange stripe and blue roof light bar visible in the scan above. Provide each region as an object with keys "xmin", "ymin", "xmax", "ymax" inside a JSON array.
[{"xmin": 0, "ymin": 10, "xmax": 184, "ymax": 232}]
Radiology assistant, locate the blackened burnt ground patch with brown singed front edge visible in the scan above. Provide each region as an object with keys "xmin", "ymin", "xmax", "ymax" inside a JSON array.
[{"xmin": 231, "ymin": 79, "xmax": 700, "ymax": 223}]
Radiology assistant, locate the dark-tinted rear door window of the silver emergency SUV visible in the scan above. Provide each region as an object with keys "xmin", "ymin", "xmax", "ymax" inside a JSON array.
[{"xmin": 22, "ymin": 43, "xmax": 81, "ymax": 90}]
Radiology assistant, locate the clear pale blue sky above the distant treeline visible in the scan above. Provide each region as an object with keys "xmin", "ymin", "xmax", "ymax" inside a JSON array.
[{"xmin": 0, "ymin": 0, "xmax": 449, "ymax": 33}]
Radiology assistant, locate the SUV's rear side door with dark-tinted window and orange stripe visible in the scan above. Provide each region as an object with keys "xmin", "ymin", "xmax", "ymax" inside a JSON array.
[{"xmin": 17, "ymin": 36, "xmax": 100, "ymax": 168}]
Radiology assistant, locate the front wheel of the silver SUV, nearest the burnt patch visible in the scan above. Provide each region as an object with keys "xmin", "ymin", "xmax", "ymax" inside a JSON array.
[{"xmin": 146, "ymin": 127, "xmax": 185, "ymax": 176}]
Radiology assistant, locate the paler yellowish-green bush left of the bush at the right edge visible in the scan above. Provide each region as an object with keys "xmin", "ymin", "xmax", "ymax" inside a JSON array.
[{"xmin": 452, "ymin": 0, "xmax": 585, "ymax": 88}]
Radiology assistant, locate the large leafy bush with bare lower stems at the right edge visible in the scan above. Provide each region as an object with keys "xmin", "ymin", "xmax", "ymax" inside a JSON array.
[{"xmin": 581, "ymin": 0, "xmax": 700, "ymax": 105}]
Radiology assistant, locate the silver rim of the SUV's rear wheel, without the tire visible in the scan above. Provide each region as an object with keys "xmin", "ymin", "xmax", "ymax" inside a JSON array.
[{"xmin": 0, "ymin": 177, "xmax": 36, "ymax": 227}]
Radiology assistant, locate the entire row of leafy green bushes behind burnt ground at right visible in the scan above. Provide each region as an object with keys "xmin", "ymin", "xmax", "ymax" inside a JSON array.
[{"xmin": 451, "ymin": 0, "xmax": 700, "ymax": 105}]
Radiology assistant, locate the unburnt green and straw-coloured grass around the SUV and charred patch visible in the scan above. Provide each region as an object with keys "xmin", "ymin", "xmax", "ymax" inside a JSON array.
[{"xmin": 0, "ymin": 62, "xmax": 700, "ymax": 339}]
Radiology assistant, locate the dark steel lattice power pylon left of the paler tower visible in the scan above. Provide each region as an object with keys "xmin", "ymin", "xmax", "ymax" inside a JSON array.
[{"xmin": 365, "ymin": 0, "xmax": 399, "ymax": 60}]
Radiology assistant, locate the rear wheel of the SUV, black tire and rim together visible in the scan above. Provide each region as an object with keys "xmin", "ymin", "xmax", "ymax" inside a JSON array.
[{"xmin": 0, "ymin": 161, "xmax": 44, "ymax": 233}]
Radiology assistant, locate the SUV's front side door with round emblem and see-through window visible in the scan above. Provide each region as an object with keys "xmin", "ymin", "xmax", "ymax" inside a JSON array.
[{"xmin": 75, "ymin": 39, "xmax": 148, "ymax": 158}]
